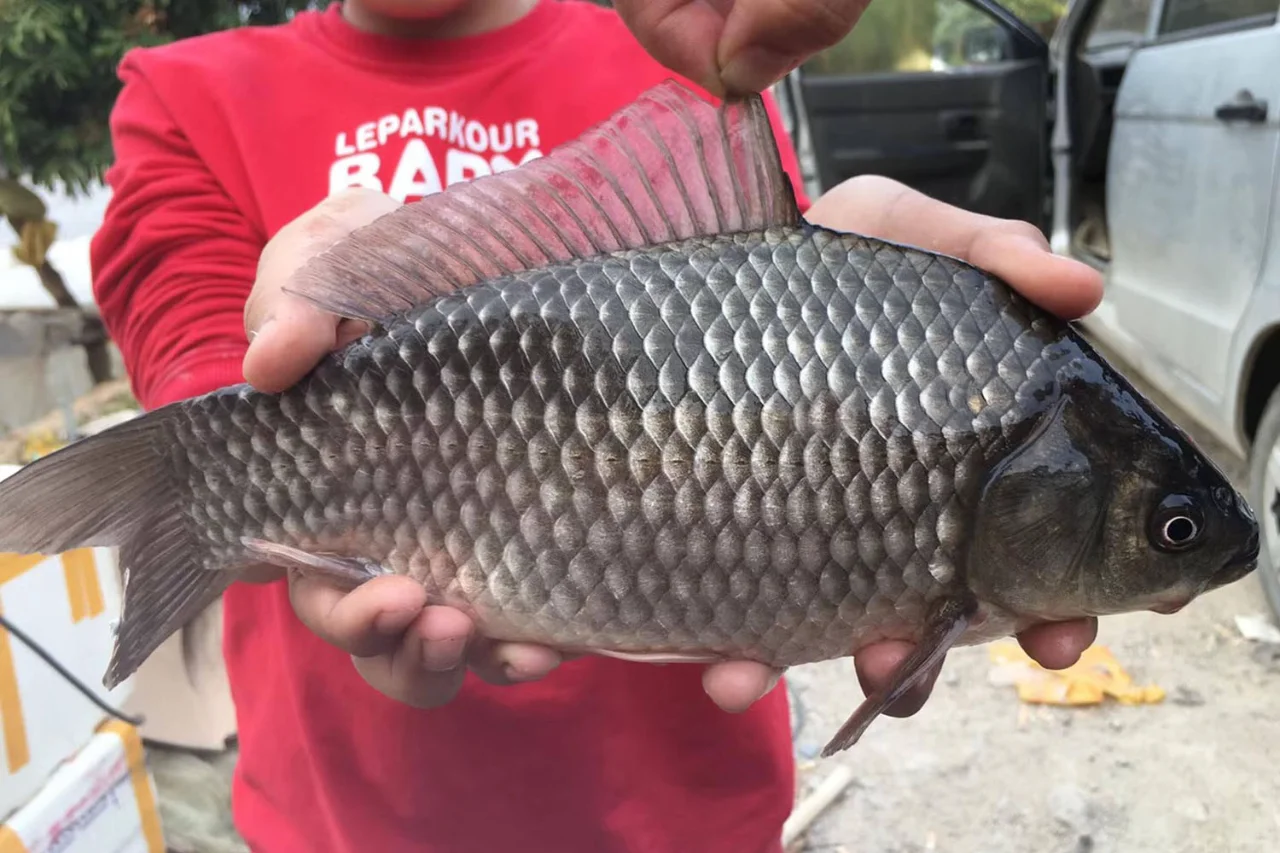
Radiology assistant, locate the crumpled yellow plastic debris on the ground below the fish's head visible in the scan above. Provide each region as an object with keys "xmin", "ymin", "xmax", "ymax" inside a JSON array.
[{"xmin": 991, "ymin": 640, "xmax": 1165, "ymax": 706}]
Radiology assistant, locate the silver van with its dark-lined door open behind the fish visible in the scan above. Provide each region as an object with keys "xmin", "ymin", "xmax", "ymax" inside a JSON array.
[{"xmin": 777, "ymin": 0, "xmax": 1280, "ymax": 616}]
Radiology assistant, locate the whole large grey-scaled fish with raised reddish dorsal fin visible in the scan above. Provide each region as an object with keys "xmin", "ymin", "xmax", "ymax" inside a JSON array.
[{"xmin": 0, "ymin": 79, "xmax": 1258, "ymax": 756}]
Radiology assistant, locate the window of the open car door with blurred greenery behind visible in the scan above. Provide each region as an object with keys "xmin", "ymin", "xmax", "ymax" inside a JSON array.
[{"xmin": 804, "ymin": 0, "xmax": 1066, "ymax": 76}]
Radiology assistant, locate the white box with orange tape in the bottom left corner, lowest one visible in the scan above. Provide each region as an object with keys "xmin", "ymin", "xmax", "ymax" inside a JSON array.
[{"xmin": 0, "ymin": 720, "xmax": 165, "ymax": 853}]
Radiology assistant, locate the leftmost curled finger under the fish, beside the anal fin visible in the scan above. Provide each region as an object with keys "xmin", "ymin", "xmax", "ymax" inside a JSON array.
[{"xmin": 289, "ymin": 573, "xmax": 426, "ymax": 657}]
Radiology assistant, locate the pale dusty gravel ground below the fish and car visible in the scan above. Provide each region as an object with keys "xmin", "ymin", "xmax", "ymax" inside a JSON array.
[{"xmin": 151, "ymin": 335, "xmax": 1280, "ymax": 853}]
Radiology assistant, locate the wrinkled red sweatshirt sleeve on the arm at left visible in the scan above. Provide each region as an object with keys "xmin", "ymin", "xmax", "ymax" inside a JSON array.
[{"xmin": 90, "ymin": 58, "xmax": 266, "ymax": 409}]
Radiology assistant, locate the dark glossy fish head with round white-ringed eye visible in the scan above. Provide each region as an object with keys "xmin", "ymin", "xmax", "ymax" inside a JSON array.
[{"xmin": 966, "ymin": 345, "xmax": 1258, "ymax": 620}]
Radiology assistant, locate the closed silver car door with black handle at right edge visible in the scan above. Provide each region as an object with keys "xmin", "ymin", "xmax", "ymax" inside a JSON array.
[{"xmin": 1102, "ymin": 0, "xmax": 1280, "ymax": 423}]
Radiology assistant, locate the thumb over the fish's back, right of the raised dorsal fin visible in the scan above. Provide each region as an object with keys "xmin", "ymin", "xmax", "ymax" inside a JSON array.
[{"xmin": 805, "ymin": 175, "xmax": 1102, "ymax": 319}]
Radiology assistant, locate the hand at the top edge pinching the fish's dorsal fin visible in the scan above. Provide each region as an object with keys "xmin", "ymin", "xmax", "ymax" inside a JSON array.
[{"xmin": 613, "ymin": 0, "xmax": 870, "ymax": 97}]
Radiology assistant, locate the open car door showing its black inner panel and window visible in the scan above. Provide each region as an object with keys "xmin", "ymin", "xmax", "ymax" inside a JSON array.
[{"xmin": 781, "ymin": 0, "xmax": 1053, "ymax": 228}]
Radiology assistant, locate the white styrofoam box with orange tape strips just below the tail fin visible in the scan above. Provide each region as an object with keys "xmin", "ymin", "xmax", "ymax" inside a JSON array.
[{"xmin": 0, "ymin": 465, "xmax": 133, "ymax": 818}]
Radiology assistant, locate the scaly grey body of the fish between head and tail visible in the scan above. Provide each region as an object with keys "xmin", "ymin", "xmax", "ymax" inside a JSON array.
[{"xmin": 165, "ymin": 229, "xmax": 1059, "ymax": 666}]
